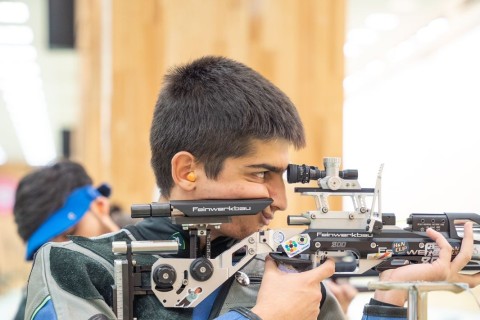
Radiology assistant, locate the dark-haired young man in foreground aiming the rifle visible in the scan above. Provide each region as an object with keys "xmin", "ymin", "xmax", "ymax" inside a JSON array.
[{"xmin": 26, "ymin": 57, "xmax": 480, "ymax": 320}]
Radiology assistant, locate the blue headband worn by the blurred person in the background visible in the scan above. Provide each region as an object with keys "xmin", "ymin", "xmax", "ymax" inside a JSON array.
[{"xmin": 26, "ymin": 186, "xmax": 101, "ymax": 260}]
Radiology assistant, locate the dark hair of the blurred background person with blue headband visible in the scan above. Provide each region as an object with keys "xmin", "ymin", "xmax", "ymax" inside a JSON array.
[{"xmin": 13, "ymin": 160, "xmax": 92, "ymax": 242}]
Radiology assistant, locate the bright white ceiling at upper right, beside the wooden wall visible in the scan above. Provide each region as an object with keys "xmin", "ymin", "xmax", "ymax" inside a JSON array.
[{"xmin": 344, "ymin": 0, "xmax": 480, "ymax": 97}]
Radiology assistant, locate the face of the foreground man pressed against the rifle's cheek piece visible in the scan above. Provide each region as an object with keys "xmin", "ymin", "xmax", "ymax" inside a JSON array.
[{"xmin": 193, "ymin": 140, "xmax": 290, "ymax": 239}]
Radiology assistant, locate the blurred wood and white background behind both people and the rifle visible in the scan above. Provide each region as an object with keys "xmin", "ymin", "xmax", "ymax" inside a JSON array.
[{"xmin": 0, "ymin": 0, "xmax": 480, "ymax": 319}]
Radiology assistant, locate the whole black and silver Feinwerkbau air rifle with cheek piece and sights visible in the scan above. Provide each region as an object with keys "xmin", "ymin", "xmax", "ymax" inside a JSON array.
[{"xmin": 112, "ymin": 158, "xmax": 480, "ymax": 319}]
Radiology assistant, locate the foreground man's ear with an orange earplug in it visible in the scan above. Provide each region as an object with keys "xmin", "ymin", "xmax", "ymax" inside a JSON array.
[{"xmin": 172, "ymin": 151, "xmax": 196, "ymax": 191}]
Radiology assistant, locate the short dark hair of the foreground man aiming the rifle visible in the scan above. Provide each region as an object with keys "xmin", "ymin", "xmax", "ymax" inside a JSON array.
[{"xmin": 150, "ymin": 56, "xmax": 305, "ymax": 197}]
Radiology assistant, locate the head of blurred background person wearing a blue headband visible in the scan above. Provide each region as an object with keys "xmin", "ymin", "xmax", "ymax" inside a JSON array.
[{"xmin": 13, "ymin": 160, "xmax": 119, "ymax": 319}]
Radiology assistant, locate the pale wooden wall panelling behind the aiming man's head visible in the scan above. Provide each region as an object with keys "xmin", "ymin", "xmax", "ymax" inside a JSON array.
[{"xmin": 80, "ymin": 0, "xmax": 345, "ymax": 225}]
